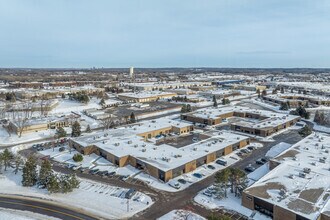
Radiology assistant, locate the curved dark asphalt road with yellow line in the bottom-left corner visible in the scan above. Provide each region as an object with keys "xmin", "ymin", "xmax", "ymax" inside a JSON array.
[{"xmin": 0, "ymin": 195, "xmax": 100, "ymax": 220}]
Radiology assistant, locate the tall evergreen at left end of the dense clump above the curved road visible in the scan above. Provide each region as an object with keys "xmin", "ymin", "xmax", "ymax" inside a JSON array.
[{"xmin": 22, "ymin": 156, "xmax": 38, "ymax": 186}]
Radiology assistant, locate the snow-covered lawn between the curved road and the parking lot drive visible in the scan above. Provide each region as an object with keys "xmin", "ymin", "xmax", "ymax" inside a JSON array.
[{"xmin": 0, "ymin": 170, "xmax": 153, "ymax": 219}]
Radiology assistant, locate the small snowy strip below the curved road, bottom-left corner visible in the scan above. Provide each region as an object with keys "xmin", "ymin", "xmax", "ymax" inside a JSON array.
[{"xmin": 0, "ymin": 208, "xmax": 58, "ymax": 220}]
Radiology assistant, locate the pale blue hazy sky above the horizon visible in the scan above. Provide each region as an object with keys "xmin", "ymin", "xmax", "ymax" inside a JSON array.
[{"xmin": 0, "ymin": 0, "xmax": 330, "ymax": 68}]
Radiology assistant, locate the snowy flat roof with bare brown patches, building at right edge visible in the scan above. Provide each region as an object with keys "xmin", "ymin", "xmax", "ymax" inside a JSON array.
[{"xmin": 246, "ymin": 133, "xmax": 330, "ymax": 219}]
